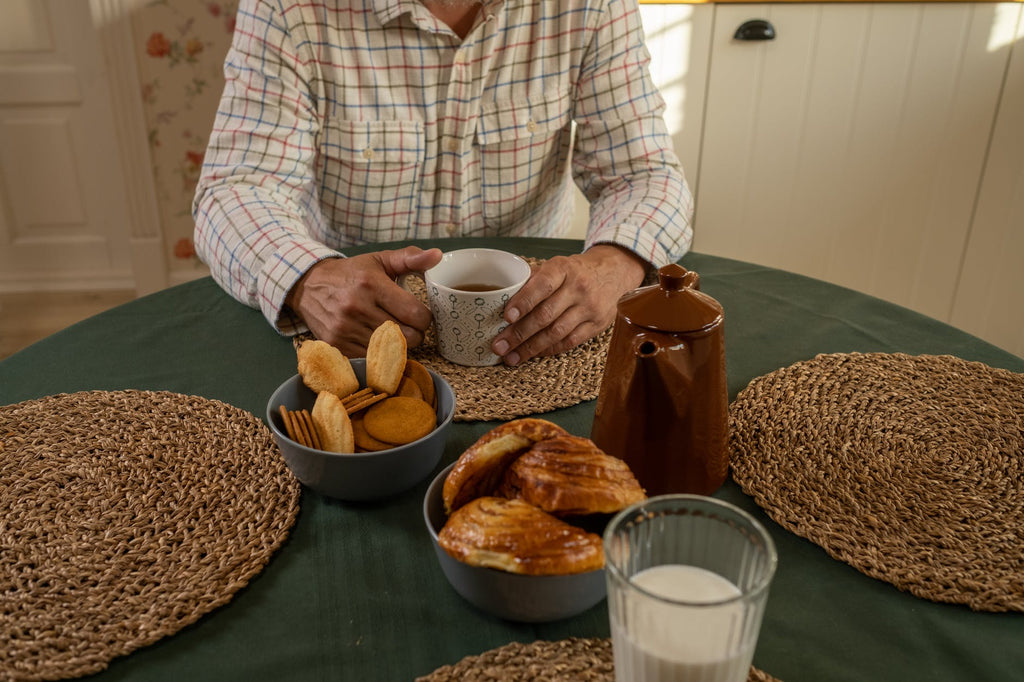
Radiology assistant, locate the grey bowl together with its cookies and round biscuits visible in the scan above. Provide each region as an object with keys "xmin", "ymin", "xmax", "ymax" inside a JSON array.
[{"xmin": 266, "ymin": 322, "xmax": 455, "ymax": 501}]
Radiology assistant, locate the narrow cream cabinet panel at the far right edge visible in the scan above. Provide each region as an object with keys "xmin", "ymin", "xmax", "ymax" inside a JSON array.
[{"xmin": 950, "ymin": 9, "xmax": 1024, "ymax": 357}]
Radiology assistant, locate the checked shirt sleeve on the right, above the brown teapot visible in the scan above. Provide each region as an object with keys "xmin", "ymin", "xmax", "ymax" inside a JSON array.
[{"xmin": 572, "ymin": 0, "xmax": 693, "ymax": 267}]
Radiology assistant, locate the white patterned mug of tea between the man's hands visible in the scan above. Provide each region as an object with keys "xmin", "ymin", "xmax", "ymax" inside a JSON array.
[{"xmin": 423, "ymin": 249, "xmax": 530, "ymax": 367}]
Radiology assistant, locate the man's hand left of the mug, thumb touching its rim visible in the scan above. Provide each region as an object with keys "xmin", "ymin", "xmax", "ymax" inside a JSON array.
[{"xmin": 286, "ymin": 247, "xmax": 441, "ymax": 357}]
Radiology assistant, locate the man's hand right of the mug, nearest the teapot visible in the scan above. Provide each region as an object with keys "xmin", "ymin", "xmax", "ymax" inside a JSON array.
[{"xmin": 492, "ymin": 244, "xmax": 647, "ymax": 365}]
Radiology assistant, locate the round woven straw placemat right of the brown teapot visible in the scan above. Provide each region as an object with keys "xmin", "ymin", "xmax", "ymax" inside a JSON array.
[{"xmin": 730, "ymin": 353, "xmax": 1024, "ymax": 611}]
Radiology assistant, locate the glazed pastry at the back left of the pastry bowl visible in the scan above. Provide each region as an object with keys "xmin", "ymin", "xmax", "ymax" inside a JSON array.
[{"xmin": 441, "ymin": 418, "xmax": 569, "ymax": 514}]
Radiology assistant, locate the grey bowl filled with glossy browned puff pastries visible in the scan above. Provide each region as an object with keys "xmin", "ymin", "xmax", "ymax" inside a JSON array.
[{"xmin": 423, "ymin": 418, "xmax": 646, "ymax": 623}]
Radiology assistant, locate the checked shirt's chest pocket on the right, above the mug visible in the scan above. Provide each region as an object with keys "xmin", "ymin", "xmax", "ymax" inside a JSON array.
[{"xmin": 476, "ymin": 88, "xmax": 571, "ymax": 226}]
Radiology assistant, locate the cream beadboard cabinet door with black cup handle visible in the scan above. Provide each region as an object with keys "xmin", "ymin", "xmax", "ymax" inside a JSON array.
[{"xmin": 694, "ymin": 3, "xmax": 1020, "ymax": 319}]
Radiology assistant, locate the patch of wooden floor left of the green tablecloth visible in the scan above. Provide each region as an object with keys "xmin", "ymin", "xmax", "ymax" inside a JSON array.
[{"xmin": 0, "ymin": 291, "xmax": 135, "ymax": 359}]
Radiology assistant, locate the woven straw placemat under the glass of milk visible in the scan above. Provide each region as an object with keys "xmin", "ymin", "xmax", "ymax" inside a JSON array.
[{"xmin": 416, "ymin": 637, "xmax": 778, "ymax": 682}]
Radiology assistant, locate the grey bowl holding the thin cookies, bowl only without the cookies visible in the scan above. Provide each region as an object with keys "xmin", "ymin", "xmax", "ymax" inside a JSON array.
[{"xmin": 266, "ymin": 358, "xmax": 455, "ymax": 501}]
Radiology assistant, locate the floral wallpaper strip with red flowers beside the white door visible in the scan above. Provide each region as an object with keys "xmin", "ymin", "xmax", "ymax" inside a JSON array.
[{"xmin": 132, "ymin": 0, "xmax": 238, "ymax": 281}]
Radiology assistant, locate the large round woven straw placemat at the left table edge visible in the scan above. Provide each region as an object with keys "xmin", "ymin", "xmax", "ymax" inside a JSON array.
[{"xmin": 0, "ymin": 390, "xmax": 301, "ymax": 680}]
